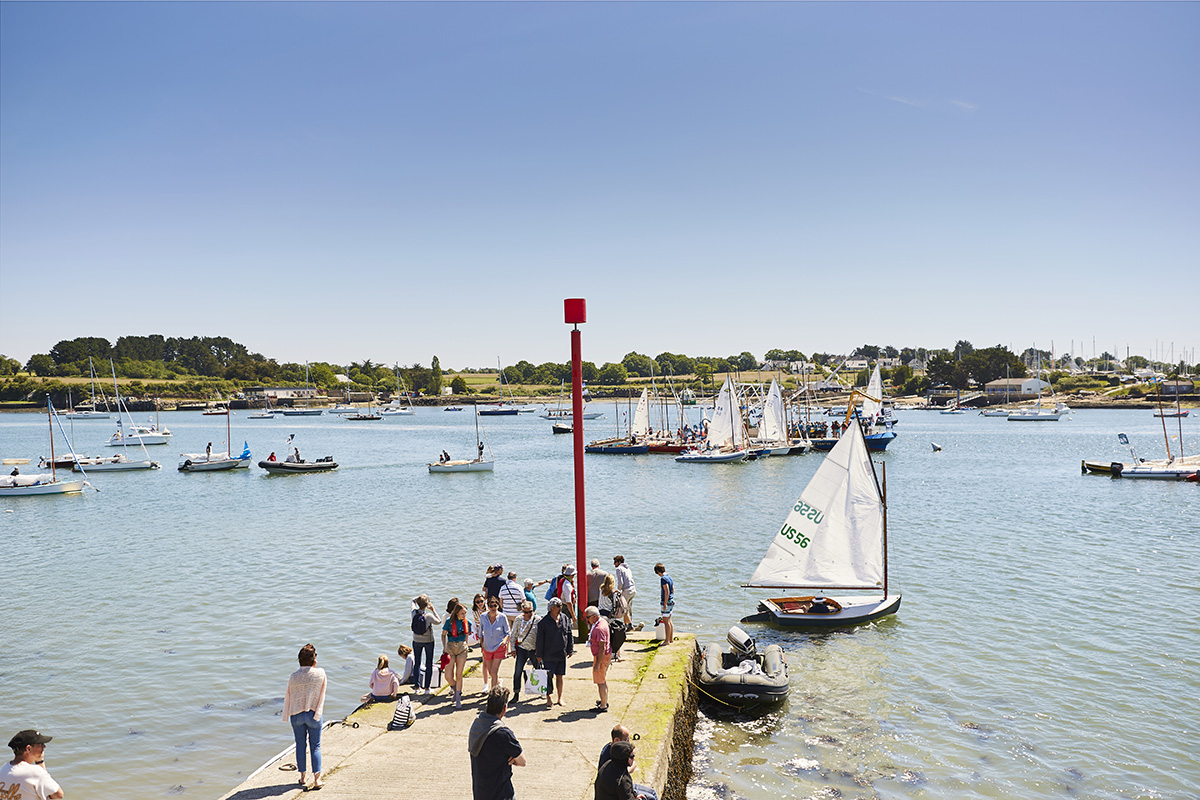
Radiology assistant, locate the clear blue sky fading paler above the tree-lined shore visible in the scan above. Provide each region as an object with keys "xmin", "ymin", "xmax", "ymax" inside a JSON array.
[{"xmin": 0, "ymin": 1, "xmax": 1200, "ymax": 368}]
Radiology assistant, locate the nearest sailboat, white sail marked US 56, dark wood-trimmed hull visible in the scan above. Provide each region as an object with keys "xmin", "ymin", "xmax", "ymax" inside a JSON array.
[{"xmin": 742, "ymin": 425, "xmax": 900, "ymax": 630}]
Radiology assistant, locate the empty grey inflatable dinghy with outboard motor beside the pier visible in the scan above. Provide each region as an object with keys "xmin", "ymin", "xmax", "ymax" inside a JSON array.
[{"xmin": 698, "ymin": 625, "xmax": 791, "ymax": 710}]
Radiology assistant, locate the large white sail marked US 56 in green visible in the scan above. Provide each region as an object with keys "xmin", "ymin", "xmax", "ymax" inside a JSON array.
[{"xmin": 746, "ymin": 425, "xmax": 884, "ymax": 589}]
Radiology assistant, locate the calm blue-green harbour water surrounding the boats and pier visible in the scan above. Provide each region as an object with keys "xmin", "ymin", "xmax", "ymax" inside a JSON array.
[{"xmin": 0, "ymin": 408, "xmax": 1200, "ymax": 800}]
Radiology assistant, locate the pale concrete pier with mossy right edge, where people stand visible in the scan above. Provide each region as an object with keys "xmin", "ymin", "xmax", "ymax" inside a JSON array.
[{"xmin": 222, "ymin": 633, "xmax": 696, "ymax": 800}]
